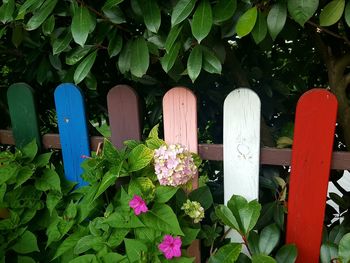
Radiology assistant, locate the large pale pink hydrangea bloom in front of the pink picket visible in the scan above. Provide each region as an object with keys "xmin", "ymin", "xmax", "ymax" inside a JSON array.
[{"xmin": 154, "ymin": 144, "xmax": 197, "ymax": 186}]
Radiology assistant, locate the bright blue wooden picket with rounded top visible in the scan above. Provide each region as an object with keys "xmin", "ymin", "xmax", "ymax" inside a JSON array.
[{"xmin": 55, "ymin": 83, "xmax": 90, "ymax": 186}]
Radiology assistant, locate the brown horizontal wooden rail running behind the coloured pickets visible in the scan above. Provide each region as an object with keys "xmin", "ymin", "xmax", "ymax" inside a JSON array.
[{"xmin": 0, "ymin": 130, "xmax": 350, "ymax": 170}]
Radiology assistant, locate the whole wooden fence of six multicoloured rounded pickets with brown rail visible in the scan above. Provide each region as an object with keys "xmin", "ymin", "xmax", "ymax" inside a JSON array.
[{"xmin": 0, "ymin": 83, "xmax": 350, "ymax": 263}]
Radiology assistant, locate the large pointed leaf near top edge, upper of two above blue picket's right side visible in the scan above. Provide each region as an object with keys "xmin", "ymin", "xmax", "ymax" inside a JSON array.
[{"xmin": 71, "ymin": 6, "xmax": 95, "ymax": 46}]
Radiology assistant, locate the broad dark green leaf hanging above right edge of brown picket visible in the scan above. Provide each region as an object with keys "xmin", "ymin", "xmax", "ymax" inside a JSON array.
[{"xmin": 130, "ymin": 37, "xmax": 149, "ymax": 78}]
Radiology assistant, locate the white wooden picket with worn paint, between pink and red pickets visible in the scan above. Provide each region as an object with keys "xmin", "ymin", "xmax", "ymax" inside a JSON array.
[{"xmin": 224, "ymin": 88, "xmax": 261, "ymax": 248}]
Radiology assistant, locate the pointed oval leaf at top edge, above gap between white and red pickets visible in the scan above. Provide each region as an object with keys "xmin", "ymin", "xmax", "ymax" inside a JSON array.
[{"xmin": 267, "ymin": 2, "xmax": 287, "ymax": 40}]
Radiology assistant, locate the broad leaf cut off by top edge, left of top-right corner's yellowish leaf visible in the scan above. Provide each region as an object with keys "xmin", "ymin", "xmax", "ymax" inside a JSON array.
[{"xmin": 288, "ymin": 0, "xmax": 319, "ymax": 26}]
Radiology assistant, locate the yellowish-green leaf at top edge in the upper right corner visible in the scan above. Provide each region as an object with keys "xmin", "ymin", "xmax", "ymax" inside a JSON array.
[{"xmin": 320, "ymin": 0, "xmax": 345, "ymax": 26}]
